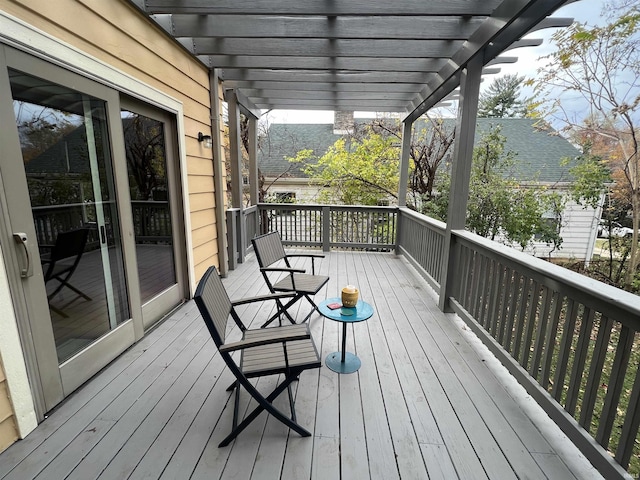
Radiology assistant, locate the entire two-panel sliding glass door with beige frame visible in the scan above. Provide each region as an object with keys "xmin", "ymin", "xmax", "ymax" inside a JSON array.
[{"xmin": 0, "ymin": 45, "xmax": 186, "ymax": 419}]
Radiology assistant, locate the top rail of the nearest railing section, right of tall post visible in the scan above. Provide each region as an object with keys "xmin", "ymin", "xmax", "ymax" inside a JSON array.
[{"xmin": 452, "ymin": 230, "xmax": 640, "ymax": 322}]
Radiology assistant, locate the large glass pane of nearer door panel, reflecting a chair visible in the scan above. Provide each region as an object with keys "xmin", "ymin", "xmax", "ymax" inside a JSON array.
[{"xmin": 9, "ymin": 69, "xmax": 130, "ymax": 363}]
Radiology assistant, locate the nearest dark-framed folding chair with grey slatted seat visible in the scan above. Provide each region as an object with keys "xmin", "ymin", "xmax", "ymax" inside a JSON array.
[{"xmin": 194, "ymin": 267, "xmax": 321, "ymax": 447}]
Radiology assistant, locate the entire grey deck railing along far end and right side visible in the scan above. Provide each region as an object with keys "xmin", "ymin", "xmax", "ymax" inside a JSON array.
[{"xmin": 226, "ymin": 204, "xmax": 640, "ymax": 478}]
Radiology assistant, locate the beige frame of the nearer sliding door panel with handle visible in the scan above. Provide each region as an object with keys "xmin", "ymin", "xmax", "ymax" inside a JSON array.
[{"xmin": 0, "ymin": 46, "xmax": 143, "ymax": 416}]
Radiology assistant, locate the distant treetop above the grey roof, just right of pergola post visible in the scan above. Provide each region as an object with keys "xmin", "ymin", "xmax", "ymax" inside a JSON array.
[{"xmin": 478, "ymin": 75, "xmax": 536, "ymax": 118}]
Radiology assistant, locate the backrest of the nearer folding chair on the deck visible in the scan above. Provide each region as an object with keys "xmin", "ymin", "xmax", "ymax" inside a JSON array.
[{"xmin": 193, "ymin": 266, "xmax": 236, "ymax": 347}]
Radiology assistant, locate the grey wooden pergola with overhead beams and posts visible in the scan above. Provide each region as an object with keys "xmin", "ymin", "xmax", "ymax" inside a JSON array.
[{"xmin": 131, "ymin": 0, "xmax": 572, "ymax": 280}]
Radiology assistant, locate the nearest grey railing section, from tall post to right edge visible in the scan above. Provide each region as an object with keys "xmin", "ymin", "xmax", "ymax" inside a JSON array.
[{"xmin": 450, "ymin": 231, "xmax": 640, "ymax": 478}]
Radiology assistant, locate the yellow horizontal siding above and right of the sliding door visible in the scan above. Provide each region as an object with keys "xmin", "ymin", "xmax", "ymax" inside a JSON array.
[{"xmin": 0, "ymin": 0, "xmax": 224, "ymax": 279}]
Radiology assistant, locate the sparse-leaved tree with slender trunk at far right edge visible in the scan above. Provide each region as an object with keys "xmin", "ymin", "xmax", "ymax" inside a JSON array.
[{"xmin": 530, "ymin": 7, "xmax": 640, "ymax": 285}]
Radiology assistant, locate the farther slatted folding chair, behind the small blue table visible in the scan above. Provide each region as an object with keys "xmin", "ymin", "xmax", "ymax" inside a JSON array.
[{"xmin": 251, "ymin": 232, "xmax": 329, "ymax": 327}]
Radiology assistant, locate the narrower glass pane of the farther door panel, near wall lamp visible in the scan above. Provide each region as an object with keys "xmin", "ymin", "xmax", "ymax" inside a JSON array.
[{"xmin": 121, "ymin": 110, "xmax": 177, "ymax": 305}]
